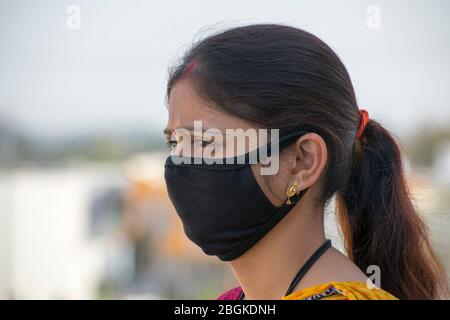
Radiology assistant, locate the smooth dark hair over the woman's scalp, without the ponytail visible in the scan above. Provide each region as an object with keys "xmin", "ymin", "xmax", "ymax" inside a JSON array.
[{"xmin": 167, "ymin": 25, "xmax": 359, "ymax": 205}]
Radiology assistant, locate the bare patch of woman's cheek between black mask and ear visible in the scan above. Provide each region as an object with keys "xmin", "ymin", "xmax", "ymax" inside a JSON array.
[{"xmin": 251, "ymin": 163, "xmax": 288, "ymax": 207}]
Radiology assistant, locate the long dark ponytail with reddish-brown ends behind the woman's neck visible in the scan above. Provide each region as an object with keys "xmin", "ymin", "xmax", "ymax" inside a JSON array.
[{"xmin": 337, "ymin": 120, "xmax": 448, "ymax": 299}]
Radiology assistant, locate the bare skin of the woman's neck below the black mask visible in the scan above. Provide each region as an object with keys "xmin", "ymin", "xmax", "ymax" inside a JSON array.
[{"xmin": 230, "ymin": 195, "xmax": 325, "ymax": 300}]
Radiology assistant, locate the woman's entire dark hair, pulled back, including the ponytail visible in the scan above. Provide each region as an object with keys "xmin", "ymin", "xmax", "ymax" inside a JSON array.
[{"xmin": 167, "ymin": 24, "xmax": 448, "ymax": 299}]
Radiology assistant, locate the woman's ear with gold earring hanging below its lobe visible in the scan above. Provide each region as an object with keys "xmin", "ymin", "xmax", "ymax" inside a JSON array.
[{"xmin": 292, "ymin": 133, "xmax": 328, "ymax": 191}]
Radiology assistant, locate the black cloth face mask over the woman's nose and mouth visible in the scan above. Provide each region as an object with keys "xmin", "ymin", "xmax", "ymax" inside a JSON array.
[{"xmin": 164, "ymin": 132, "xmax": 307, "ymax": 261}]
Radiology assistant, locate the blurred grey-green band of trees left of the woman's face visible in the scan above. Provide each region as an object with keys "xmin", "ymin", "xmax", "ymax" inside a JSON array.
[{"xmin": 0, "ymin": 122, "xmax": 165, "ymax": 168}]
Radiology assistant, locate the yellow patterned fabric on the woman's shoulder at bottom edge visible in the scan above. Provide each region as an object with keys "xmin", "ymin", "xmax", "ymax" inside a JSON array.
[{"xmin": 282, "ymin": 281, "xmax": 398, "ymax": 300}]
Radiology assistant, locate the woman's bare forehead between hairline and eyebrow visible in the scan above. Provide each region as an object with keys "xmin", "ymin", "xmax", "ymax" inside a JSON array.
[{"xmin": 167, "ymin": 80, "xmax": 254, "ymax": 131}]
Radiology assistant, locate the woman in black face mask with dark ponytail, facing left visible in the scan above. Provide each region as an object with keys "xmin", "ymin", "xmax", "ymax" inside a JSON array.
[{"xmin": 165, "ymin": 24, "xmax": 447, "ymax": 300}]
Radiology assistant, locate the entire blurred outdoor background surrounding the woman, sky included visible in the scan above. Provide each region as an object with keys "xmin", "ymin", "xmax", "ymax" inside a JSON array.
[{"xmin": 0, "ymin": 0, "xmax": 450, "ymax": 299}]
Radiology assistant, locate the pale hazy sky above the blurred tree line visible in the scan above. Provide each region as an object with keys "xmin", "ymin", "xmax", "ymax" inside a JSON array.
[{"xmin": 0, "ymin": 0, "xmax": 450, "ymax": 136}]
